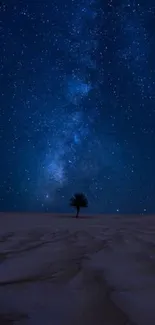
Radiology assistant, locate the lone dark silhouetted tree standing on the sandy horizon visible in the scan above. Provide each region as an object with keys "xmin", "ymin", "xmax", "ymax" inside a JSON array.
[{"xmin": 70, "ymin": 193, "xmax": 88, "ymax": 218}]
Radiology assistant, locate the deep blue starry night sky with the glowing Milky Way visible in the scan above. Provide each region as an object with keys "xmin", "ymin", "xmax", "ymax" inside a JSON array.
[{"xmin": 0, "ymin": 0, "xmax": 155, "ymax": 213}]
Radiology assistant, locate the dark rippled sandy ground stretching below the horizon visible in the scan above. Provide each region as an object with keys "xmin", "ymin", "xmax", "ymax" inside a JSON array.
[{"xmin": 0, "ymin": 213, "xmax": 155, "ymax": 325}]
